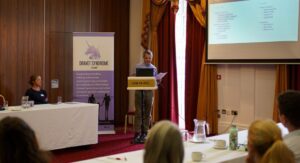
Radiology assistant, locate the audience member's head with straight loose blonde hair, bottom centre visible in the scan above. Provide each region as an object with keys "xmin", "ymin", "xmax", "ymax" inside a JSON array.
[{"xmin": 144, "ymin": 121, "xmax": 184, "ymax": 163}]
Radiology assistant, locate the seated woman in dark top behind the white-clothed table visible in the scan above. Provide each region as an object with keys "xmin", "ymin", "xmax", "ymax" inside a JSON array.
[{"xmin": 25, "ymin": 75, "xmax": 48, "ymax": 104}]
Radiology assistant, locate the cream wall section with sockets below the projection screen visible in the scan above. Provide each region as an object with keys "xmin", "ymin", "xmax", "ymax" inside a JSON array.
[{"xmin": 218, "ymin": 65, "xmax": 276, "ymax": 133}]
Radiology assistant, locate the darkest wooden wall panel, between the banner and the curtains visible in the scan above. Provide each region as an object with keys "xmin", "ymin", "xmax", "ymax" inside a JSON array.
[{"xmin": 91, "ymin": 0, "xmax": 130, "ymax": 124}]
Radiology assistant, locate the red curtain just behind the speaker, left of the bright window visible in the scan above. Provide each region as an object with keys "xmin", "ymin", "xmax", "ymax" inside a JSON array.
[{"xmin": 157, "ymin": 5, "xmax": 178, "ymax": 123}]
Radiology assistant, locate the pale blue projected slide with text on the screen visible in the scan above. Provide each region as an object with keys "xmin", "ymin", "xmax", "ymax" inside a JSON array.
[{"xmin": 208, "ymin": 0, "xmax": 299, "ymax": 44}]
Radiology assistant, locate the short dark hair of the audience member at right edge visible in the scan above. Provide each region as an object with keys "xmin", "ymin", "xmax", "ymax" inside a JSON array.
[{"xmin": 278, "ymin": 90, "xmax": 300, "ymax": 128}]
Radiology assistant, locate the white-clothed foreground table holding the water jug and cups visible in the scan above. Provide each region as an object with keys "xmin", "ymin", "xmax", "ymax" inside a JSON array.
[{"xmin": 78, "ymin": 130, "xmax": 248, "ymax": 163}]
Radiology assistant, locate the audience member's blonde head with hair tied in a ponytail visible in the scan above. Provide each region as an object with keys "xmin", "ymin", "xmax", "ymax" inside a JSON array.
[{"xmin": 247, "ymin": 120, "xmax": 295, "ymax": 163}]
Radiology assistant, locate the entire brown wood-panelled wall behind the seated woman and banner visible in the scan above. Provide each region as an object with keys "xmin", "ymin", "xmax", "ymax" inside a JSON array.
[{"xmin": 0, "ymin": 0, "xmax": 130, "ymax": 124}]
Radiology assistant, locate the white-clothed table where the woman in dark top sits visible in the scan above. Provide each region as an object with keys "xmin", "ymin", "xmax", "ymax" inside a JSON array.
[{"xmin": 0, "ymin": 102, "xmax": 98, "ymax": 150}]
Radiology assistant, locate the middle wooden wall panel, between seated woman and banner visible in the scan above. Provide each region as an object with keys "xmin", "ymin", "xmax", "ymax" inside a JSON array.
[{"xmin": 46, "ymin": 0, "xmax": 90, "ymax": 102}]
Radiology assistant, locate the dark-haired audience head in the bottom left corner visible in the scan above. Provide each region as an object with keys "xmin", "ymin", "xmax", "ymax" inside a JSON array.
[{"xmin": 0, "ymin": 117, "xmax": 50, "ymax": 163}]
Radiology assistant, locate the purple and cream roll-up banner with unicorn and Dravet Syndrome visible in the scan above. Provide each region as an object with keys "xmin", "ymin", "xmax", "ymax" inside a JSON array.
[{"xmin": 73, "ymin": 32, "xmax": 115, "ymax": 134}]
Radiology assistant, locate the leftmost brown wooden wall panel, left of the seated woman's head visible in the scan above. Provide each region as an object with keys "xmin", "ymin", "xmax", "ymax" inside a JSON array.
[{"xmin": 0, "ymin": 0, "xmax": 44, "ymax": 105}]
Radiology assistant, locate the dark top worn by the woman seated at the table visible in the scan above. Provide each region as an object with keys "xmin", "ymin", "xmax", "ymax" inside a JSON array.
[{"xmin": 25, "ymin": 88, "xmax": 47, "ymax": 104}]
